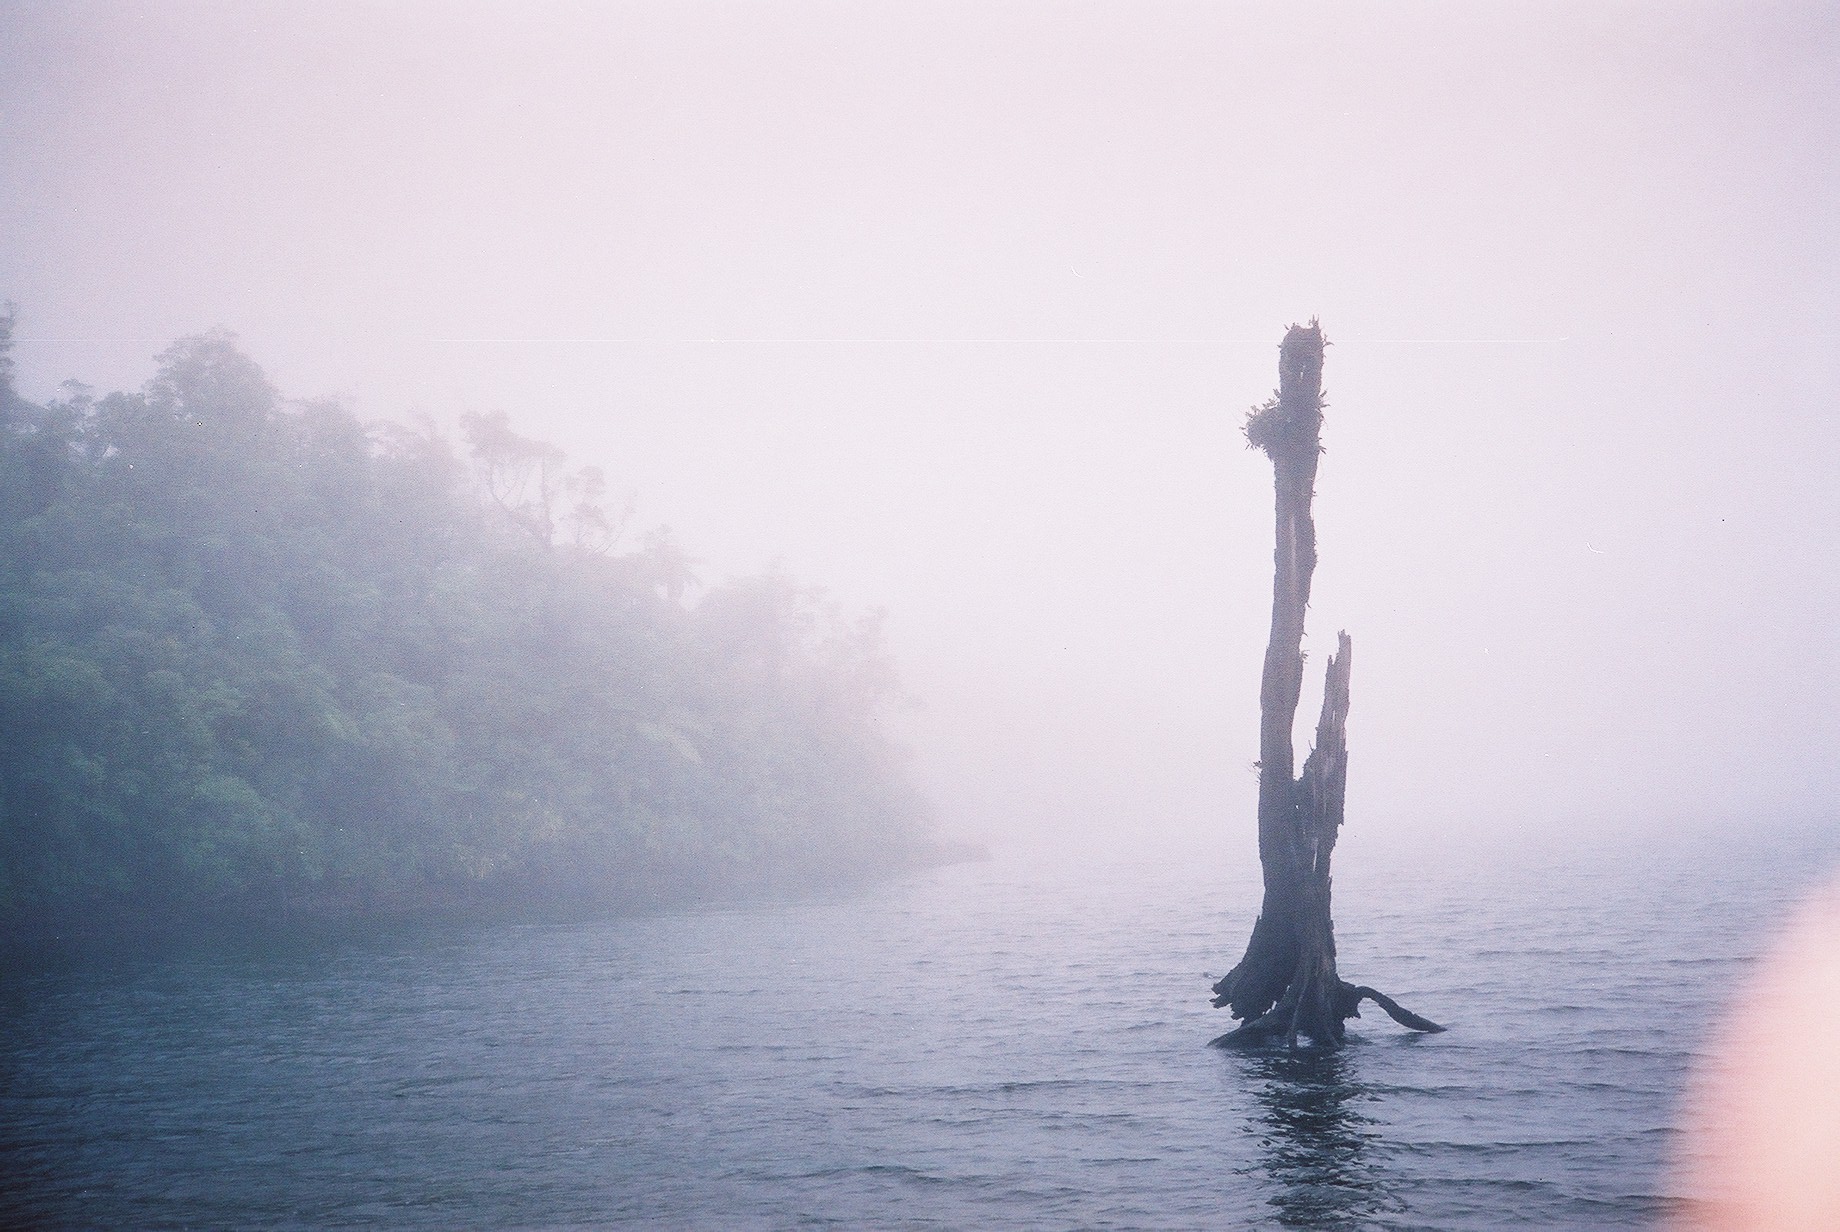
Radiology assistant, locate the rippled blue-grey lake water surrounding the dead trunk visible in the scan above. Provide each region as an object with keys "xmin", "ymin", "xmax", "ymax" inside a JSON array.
[{"xmin": 0, "ymin": 829, "xmax": 1840, "ymax": 1228}]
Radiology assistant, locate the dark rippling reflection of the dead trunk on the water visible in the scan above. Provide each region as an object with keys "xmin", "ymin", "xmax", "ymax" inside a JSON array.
[{"xmin": 1244, "ymin": 1048, "xmax": 1400, "ymax": 1228}]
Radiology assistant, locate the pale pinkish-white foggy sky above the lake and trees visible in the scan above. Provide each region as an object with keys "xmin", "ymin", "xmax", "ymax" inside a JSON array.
[{"xmin": 0, "ymin": 0, "xmax": 1840, "ymax": 860}]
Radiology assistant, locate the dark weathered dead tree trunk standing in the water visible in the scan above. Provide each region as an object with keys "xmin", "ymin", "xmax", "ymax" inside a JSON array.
[{"xmin": 1213, "ymin": 320, "xmax": 1444, "ymax": 1048}]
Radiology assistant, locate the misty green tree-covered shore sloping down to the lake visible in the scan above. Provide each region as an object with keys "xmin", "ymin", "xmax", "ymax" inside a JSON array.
[{"xmin": 0, "ymin": 322, "xmax": 924, "ymax": 919}]
